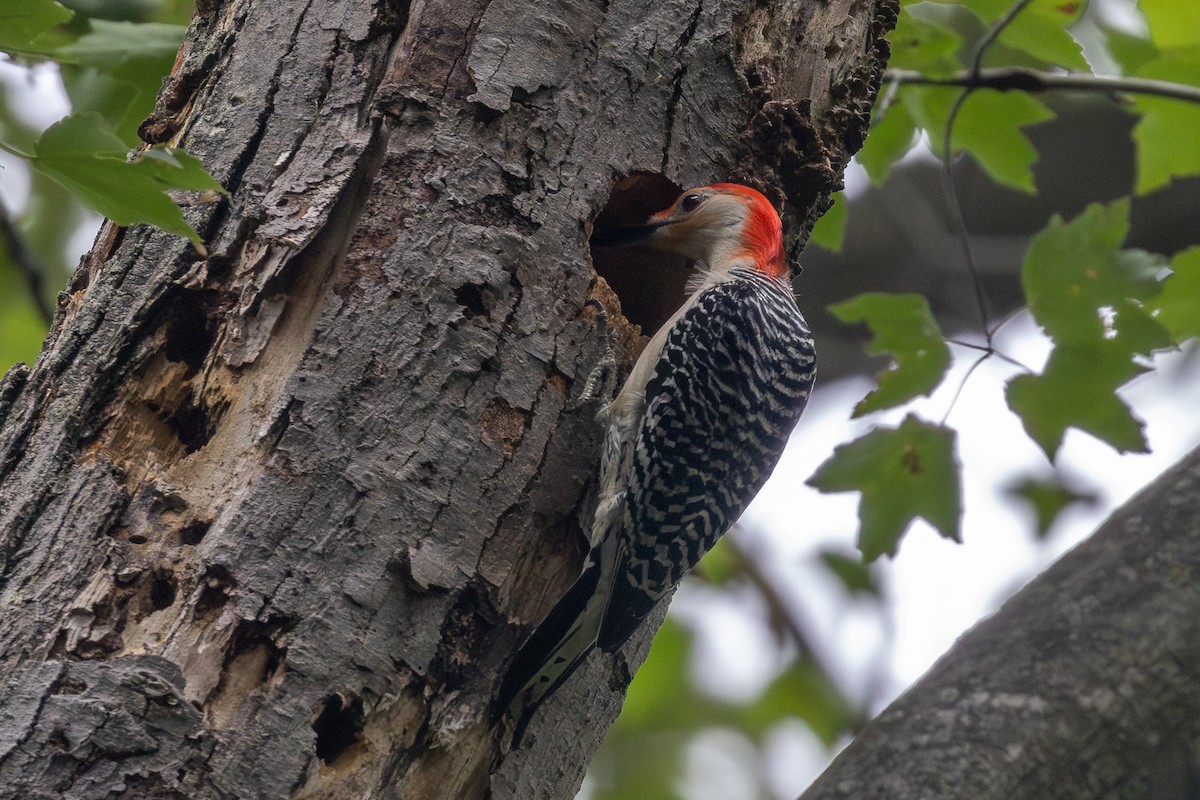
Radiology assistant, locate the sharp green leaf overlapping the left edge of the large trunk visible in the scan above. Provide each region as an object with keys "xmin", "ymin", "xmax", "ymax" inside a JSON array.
[{"xmin": 32, "ymin": 112, "xmax": 224, "ymax": 246}]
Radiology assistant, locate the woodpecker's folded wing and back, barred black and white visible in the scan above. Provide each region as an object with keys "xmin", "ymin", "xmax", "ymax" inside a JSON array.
[{"xmin": 598, "ymin": 269, "xmax": 816, "ymax": 651}]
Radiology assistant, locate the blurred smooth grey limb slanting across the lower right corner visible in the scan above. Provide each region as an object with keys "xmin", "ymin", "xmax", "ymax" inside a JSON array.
[{"xmin": 803, "ymin": 452, "xmax": 1200, "ymax": 800}]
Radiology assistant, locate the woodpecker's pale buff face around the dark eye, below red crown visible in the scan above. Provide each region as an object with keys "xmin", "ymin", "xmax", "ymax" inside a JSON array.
[{"xmin": 648, "ymin": 187, "xmax": 750, "ymax": 266}]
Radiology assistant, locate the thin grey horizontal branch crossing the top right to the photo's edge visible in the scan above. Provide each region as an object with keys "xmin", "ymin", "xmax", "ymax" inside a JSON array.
[{"xmin": 883, "ymin": 67, "xmax": 1200, "ymax": 103}]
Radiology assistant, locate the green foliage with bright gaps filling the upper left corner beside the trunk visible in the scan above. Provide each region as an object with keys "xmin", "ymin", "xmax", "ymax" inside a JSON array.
[{"xmin": 0, "ymin": 0, "xmax": 213, "ymax": 369}]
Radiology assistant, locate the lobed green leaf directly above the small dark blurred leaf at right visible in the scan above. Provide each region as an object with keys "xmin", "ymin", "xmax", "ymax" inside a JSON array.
[{"xmin": 1006, "ymin": 344, "xmax": 1150, "ymax": 461}]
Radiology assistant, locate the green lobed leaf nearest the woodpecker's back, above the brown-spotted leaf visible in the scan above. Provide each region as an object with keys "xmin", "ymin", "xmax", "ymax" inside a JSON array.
[{"xmin": 829, "ymin": 293, "xmax": 950, "ymax": 416}]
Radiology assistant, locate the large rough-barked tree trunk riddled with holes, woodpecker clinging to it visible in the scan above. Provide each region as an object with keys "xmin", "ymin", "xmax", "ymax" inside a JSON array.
[{"xmin": 0, "ymin": 0, "xmax": 896, "ymax": 799}]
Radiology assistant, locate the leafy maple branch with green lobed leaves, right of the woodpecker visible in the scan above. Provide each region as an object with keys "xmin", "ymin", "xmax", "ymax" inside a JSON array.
[{"xmin": 809, "ymin": 0, "xmax": 1200, "ymax": 560}]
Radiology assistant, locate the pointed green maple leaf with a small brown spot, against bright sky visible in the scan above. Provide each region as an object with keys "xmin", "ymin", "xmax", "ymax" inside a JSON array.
[{"xmin": 808, "ymin": 414, "xmax": 962, "ymax": 561}]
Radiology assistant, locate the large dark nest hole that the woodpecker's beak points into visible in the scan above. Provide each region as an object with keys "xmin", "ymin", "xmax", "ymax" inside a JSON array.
[{"xmin": 592, "ymin": 173, "xmax": 691, "ymax": 336}]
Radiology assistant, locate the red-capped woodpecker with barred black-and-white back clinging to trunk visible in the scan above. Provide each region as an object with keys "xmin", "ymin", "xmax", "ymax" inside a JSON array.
[{"xmin": 498, "ymin": 184, "xmax": 816, "ymax": 738}]
